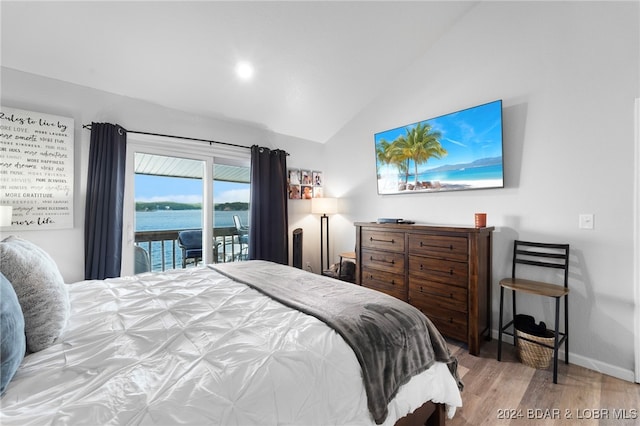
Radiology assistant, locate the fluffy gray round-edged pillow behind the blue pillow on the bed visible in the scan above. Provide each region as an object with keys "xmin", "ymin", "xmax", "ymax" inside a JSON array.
[{"xmin": 0, "ymin": 236, "xmax": 70, "ymax": 352}]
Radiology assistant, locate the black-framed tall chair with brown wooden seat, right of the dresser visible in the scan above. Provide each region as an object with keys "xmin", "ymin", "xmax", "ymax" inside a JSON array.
[{"xmin": 498, "ymin": 240, "xmax": 569, "ymax": 383}]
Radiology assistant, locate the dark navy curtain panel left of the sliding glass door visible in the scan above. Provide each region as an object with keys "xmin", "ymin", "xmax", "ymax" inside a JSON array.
[{"xmin": 84, "ymin": 123, "xmax": 127, "ymax": 280}]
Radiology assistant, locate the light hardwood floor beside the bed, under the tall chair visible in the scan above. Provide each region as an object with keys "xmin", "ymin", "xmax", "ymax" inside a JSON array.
[{"xmin": 446, "ymin": 339, "xmax": 640, "ymax": 426}]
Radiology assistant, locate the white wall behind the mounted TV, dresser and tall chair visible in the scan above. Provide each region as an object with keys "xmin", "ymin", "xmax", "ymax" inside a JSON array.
[{"xmin": 325, "ymin": 2, "xmax": 640, "ymax": 380}]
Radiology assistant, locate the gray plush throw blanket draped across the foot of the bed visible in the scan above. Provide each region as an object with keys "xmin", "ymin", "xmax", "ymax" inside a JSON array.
[{"xmin": 210, "ymin": 260, "xmax": 462, "ymax": 424}]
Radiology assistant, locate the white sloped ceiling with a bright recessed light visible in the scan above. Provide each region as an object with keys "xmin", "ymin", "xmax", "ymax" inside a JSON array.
[{"xmin": 0, "ymin": 0, "xmax": 477, "ymax": 142}]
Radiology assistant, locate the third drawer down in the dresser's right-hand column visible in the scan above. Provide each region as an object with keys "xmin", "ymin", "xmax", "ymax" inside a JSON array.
[{"xmin": 409, "ymin": 277, "xmax": 468, "ymax": 314}]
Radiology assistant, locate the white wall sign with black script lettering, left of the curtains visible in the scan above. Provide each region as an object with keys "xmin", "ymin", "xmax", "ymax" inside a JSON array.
[{"xmin": 0, "ymin": 106, "xmax": 75, "ymax": 231}]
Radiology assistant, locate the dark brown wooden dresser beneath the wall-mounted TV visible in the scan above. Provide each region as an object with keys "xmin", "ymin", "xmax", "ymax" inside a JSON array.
[{"xmin": 355, "ymin": 222, "xmax": 494, "ymax": 355}]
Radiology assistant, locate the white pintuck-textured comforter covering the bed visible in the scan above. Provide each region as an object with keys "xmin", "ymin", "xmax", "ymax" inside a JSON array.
[{"xmin": 0, "ymin": 268, "xmax": 461, "ymax": 425}]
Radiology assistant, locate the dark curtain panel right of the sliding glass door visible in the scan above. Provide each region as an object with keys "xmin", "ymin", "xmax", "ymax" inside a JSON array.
[{"xmin": 249, "ymin": 145, "xmax": 289, "ymax": 265}]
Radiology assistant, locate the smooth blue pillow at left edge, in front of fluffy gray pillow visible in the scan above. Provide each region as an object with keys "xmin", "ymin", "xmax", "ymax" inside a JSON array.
[{"xmin": 0, "ymin": 273, "xmax": 27, "ymax": 395}]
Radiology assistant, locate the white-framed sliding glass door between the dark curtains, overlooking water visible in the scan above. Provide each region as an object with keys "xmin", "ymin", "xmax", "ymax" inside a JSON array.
[{"xmin": 122, "ymin": 137, "xmax": 250, "ymax": 275}]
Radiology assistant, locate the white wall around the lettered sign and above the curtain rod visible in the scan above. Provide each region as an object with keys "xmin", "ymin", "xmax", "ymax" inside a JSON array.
[{"xmin": 0, "ymin": 68, "xmax": 322, "ymax": 283}]
